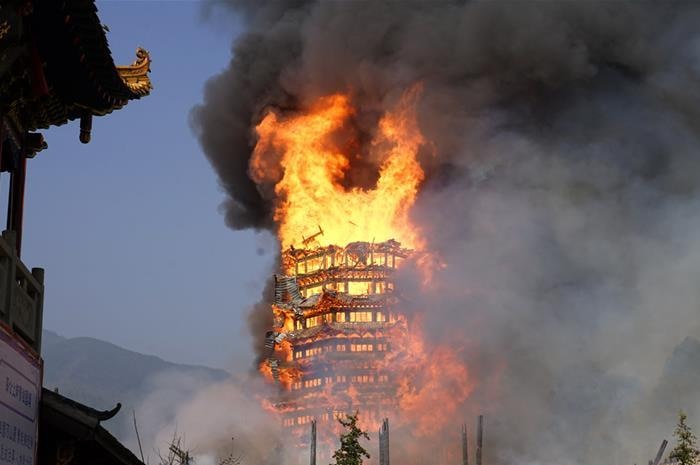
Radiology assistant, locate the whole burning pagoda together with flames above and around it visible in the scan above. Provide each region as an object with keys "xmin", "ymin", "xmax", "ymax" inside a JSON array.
[{"xmin": 249, "ymin": 86, "xmax": 467, "ymax": 445}]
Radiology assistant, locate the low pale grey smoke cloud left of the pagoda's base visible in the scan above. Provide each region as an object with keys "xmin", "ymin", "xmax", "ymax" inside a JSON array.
[{"xmin": 129, "ymin": 372, "xmax": 292, "ymax": 465}]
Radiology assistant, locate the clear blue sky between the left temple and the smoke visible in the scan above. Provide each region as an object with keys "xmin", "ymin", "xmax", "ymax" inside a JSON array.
[{"xmin": 22, "ymin": 0, "xmax": 273, "ymax": 369}]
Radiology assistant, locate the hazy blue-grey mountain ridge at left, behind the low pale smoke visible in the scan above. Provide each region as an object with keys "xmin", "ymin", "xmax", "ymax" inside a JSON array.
[{"xmin": 42, "ymin": 330, "xmax": 230, "ymax": 437}]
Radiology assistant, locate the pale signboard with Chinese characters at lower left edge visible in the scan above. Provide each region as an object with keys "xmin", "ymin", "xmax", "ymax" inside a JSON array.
[{"xmin": 0, "ymin": 328, "xmax": 41, "ymax": 465}]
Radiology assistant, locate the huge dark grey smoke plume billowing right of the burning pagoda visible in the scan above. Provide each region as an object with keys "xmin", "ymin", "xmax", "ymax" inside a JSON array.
[{"xmin": 193, "ymin": 1, "xmax": 700, "ymax": 464}]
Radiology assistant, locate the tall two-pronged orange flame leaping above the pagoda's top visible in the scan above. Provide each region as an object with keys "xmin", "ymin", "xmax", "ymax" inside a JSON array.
[{"xmin": 250, "ymin": 86, "xmax": 424, "ymax": 249}]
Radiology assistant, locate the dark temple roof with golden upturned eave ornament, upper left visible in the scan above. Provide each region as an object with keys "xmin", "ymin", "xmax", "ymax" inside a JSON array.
[{"xmin": 0, "ymin": 0, "xmax": 152, "ymax": 136}]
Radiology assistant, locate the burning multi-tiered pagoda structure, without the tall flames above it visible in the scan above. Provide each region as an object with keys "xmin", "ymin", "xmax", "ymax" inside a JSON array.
[{"xmin": 266, "ymin": 236, "xmax": 411, "ymax": 436}]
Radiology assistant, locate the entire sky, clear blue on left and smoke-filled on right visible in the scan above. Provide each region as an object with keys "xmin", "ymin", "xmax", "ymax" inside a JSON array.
[{"xmin": 25, "ymin": 1, "xmax": 700, "ymax": 465}]
